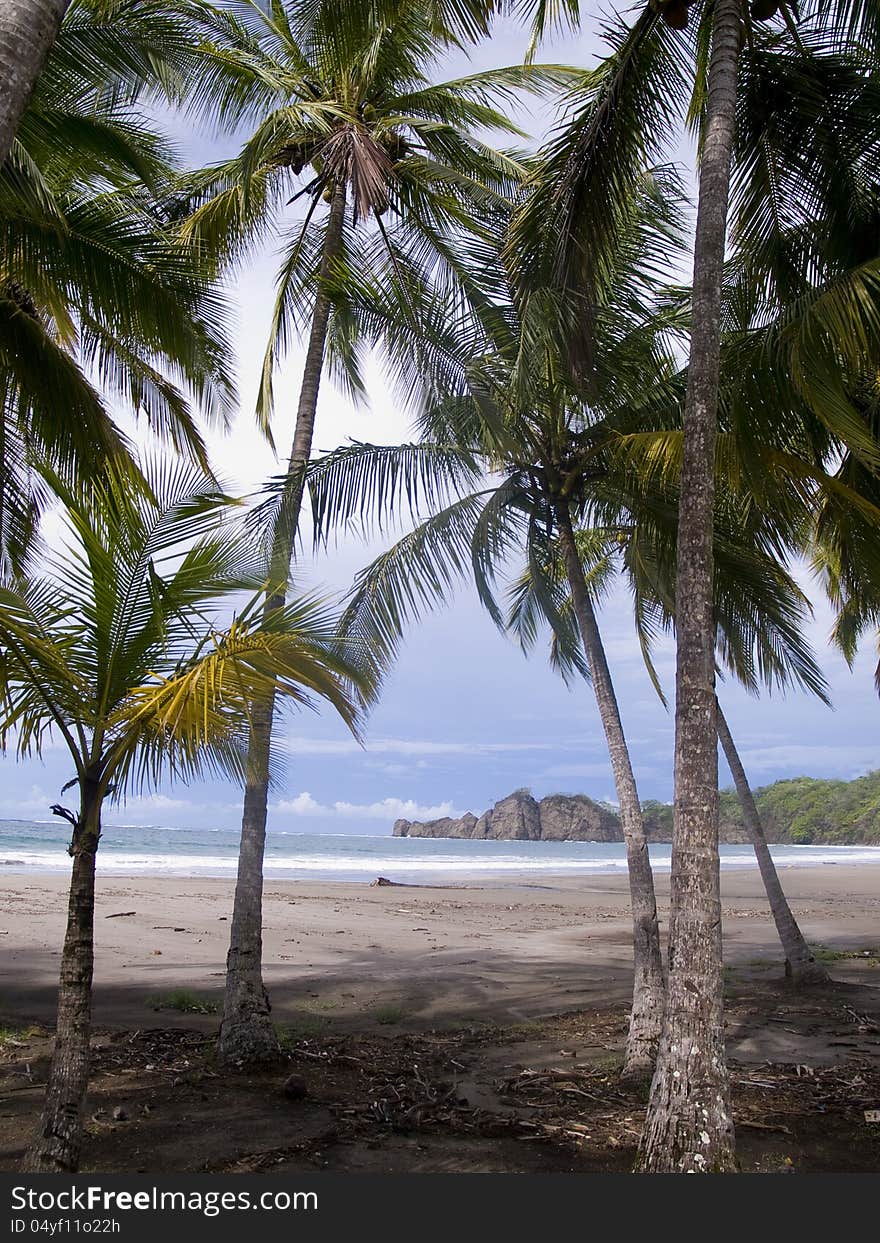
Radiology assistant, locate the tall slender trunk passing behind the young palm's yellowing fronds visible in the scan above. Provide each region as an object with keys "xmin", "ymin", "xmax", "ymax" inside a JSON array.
[{"xmin": 219, "ymin": 183, "xmax": 346, "ymax": 1064}]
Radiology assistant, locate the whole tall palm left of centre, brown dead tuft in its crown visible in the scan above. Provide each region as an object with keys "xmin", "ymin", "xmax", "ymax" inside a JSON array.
[{"xmin": 185, "ymin": 0, "xmax": 574, "ymax": 1063}]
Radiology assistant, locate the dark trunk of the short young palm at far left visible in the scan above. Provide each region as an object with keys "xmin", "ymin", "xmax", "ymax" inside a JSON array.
[{"xmin": 22, "ymin": 782, "xmax": 101, "ymax": 1173}]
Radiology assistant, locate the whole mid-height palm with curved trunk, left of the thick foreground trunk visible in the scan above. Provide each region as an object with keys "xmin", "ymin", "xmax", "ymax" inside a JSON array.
[{"xmin": 302, "ymin": 173, "xmax": 679, "ymax": 1076}]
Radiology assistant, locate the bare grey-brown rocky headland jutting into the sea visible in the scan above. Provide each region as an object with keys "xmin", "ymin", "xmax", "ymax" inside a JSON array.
[{"xmin": 393, "ymin": 789, "xmax": 623, "ymax": 842}]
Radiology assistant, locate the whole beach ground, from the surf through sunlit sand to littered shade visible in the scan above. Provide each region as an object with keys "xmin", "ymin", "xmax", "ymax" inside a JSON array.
[{"xmin": 0, "ymin": 865, "xmax": 880, "ymax": 1175}]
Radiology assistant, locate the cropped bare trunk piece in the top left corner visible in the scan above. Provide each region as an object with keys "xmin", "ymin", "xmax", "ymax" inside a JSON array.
[{"xmin": 0, "ymin": 0, "xmax": 70, "ymax": 164}]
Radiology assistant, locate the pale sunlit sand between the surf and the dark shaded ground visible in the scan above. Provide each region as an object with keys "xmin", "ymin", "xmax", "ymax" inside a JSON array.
[{"xmin": 0, "ymin": 865, "xmax": 880, "ymax": 1030}]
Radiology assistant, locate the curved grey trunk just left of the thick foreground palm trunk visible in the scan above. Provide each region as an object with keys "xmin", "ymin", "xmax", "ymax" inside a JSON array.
[{"xmin": 557, "ymin": 502, "xmax": 666, "ymax": 1079}]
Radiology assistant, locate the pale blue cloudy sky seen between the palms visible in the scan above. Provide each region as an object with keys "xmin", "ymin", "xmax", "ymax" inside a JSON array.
[{"xmin": 0, "ymin": 9, "xmax": 880, "ymax": 835}]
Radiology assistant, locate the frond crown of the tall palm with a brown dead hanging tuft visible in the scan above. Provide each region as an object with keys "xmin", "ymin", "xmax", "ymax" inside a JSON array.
[{"xmin": 175, "ymin": 0, "xmax": 574, "ymax": 433}]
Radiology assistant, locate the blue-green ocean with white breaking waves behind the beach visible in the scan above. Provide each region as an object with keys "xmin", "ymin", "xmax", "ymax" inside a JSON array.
[{"xmin": 0, "ymin": 820, "xmax": 880, "ymax": 884}]
